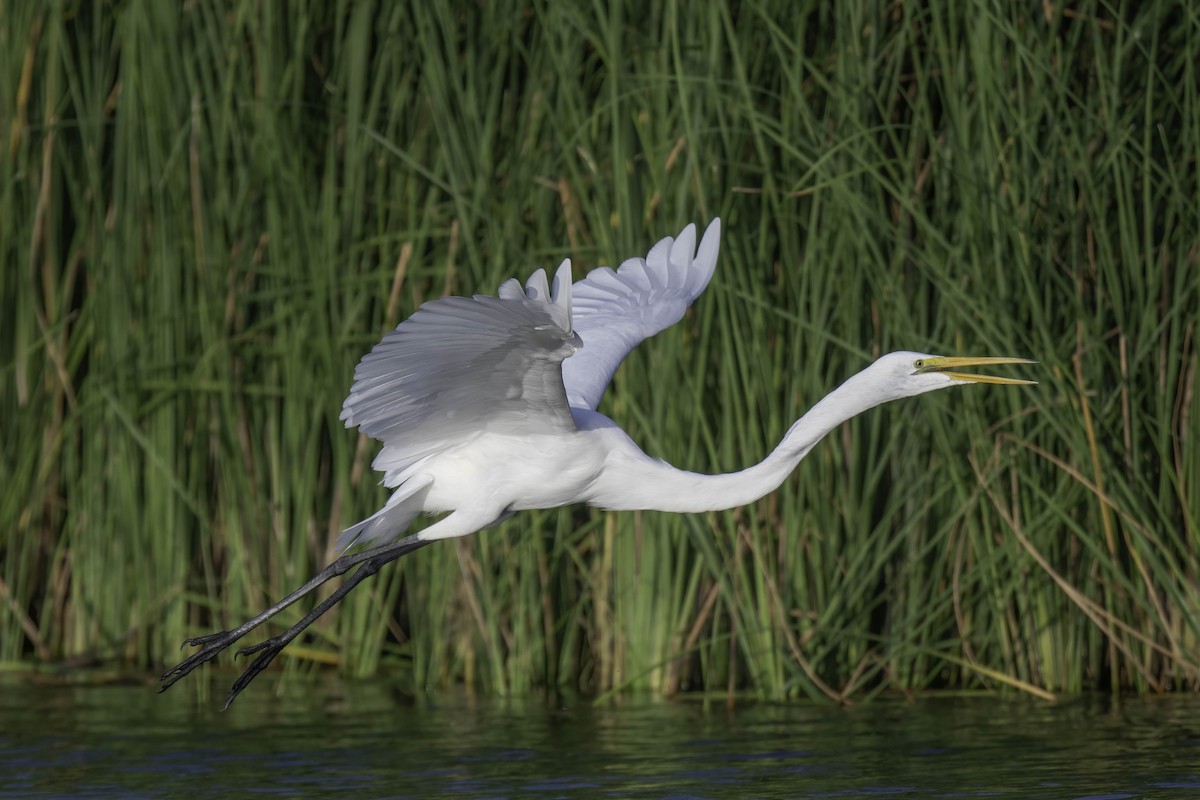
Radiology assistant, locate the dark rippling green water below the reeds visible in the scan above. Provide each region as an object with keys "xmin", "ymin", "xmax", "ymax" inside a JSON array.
[{"xmin": 0, "ymin": 681, "xmax": 1200, "ymax": 800}]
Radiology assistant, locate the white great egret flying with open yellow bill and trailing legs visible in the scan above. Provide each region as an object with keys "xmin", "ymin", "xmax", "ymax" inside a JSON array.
[{"xmin": 162, "ymin": 219, "xmax": 1033, "ymax": 708}]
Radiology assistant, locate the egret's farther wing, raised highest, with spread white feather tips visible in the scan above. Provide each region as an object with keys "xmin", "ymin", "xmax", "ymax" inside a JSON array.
[{"xmin": 563, "ymin": 218, "xmax": 721, "ymax": 410}]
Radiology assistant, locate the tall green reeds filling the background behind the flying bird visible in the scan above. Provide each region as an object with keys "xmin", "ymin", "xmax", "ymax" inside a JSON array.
[{"xmin": 0, "ymin": 0, "xmax": 1200, "ymax": 698}]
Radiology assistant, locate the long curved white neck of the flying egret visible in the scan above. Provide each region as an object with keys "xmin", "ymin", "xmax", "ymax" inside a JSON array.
[{"xmin": 589, "ymin": 372, "xmax": 893, "ymax": 511}]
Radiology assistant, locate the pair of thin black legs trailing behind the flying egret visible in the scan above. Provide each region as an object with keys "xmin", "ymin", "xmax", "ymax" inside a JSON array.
[{"xmin": 158, "ymin": 534, "xmax": 430, "ymax": 708}]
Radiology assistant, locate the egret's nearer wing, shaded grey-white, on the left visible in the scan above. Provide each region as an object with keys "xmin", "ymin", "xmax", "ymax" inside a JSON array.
[{"xmin": 341, "ymin": 261, "xmax": 580, "ymax": 476}]
